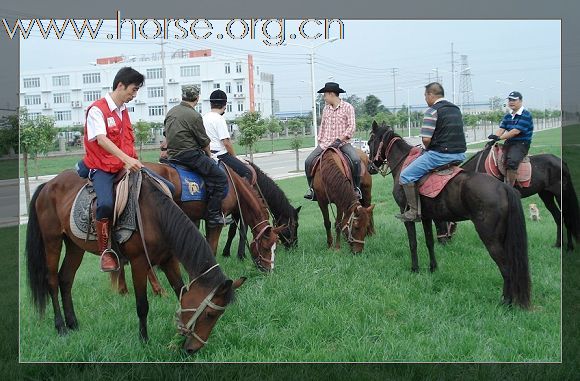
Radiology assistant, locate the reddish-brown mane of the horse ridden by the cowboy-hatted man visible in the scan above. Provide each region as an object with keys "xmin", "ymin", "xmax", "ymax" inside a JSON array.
[{"xmin": 319, "ymin": 151, "xmax": 357, "ymax": 210}]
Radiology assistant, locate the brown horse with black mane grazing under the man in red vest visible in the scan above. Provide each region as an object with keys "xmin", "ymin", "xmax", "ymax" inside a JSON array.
[{"xmin": 26, "ymin": 171, "xmax": 244, "ymax": 352}]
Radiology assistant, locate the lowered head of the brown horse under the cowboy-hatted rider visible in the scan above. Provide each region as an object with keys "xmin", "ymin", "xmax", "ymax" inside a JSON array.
[{"xmin": 340, "ymin": 201, "xmax": 375, "ymax": 254}]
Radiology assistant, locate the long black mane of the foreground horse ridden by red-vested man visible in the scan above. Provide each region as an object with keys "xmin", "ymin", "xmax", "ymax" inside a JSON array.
[{"xmin": 141, "ymin": 175, "xmax": 234, "ymax": 304}]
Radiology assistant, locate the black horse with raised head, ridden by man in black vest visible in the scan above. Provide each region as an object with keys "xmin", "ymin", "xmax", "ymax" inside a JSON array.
[{"xmin": 369, "ymin": 122, "xmax": 531, "ymax": 308}]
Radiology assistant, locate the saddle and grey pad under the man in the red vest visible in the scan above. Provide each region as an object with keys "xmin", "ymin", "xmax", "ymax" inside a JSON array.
[{"xmin": 69, "ymin": 171, "xmax": 141, "ymax": 244}]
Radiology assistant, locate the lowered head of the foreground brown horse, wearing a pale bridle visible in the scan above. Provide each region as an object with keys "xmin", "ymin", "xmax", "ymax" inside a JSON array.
[{"xmin": 176, "ymin": 267, "xmax": 246, "ymax": 354}]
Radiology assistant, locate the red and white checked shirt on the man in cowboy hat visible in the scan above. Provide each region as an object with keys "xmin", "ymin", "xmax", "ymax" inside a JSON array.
[{"xmin": 318, "ymin": 99, "xmax": 356, "ymax": 149}]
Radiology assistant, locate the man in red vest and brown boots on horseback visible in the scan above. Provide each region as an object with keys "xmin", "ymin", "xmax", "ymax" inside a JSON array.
[{"xmin": 83, "ymin": 67, "xmax": 145, "ymax": 272}]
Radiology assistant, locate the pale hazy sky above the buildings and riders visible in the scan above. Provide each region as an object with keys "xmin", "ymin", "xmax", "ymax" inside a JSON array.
[{"xmin": 20, "ymin": 19, "xmax": 561, "ymax": 111}]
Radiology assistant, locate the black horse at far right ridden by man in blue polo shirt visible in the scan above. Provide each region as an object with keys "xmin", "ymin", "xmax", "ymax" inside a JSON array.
[{"xmin": 438, "ymin": 145, "xmax": 580, "ymax": 251}]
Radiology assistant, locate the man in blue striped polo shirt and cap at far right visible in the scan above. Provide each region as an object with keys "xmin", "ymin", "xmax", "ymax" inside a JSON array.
[{"xmin": 488, "ymin": 91, "xmax": 534, "ymax": 186}]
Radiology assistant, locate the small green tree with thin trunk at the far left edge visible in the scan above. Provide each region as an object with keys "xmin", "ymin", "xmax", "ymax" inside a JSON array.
[{"xmin": 19, "ymin": 108, "xmax": 57, "ymax": 209}]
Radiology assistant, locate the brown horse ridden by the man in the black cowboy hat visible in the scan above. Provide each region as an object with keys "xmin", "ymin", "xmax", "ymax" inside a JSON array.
[{"xmin": 312, "ymin": 149, "xmax": 375, "ymax": 253}]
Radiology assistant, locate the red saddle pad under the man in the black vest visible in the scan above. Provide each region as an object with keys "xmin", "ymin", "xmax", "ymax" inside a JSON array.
[{"xmin": 402, "ymin": 147, "xmax": 463, "ymax": 198}]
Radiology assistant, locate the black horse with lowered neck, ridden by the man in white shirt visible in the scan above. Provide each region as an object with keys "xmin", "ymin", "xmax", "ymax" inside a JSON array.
[{"xmin": 222, "ymin": 163, "xmax": 302, "ymax": 259}]
